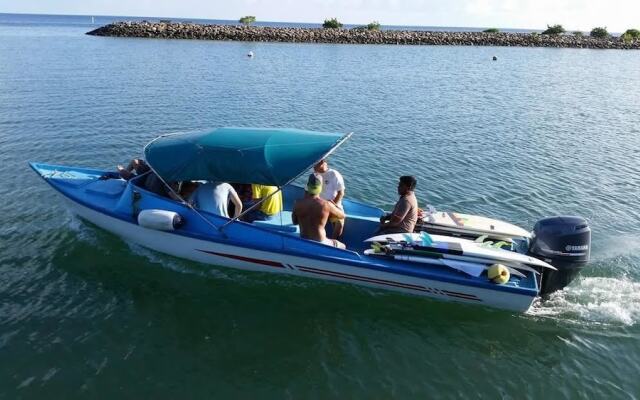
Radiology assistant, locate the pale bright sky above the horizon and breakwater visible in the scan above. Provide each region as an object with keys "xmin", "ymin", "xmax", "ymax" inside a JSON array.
[{"xmin": 0, "ymin": 0, "xmax": 640, "ymax": 32}]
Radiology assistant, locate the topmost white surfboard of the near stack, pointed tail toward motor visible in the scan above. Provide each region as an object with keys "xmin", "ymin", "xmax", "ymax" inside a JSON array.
[{"xmin": 365, "ymin": 233, "xmax": 556, "ymax": 269}]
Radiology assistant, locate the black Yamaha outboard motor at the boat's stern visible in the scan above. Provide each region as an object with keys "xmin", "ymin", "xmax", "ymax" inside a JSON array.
[{"xmin": 529, "ymin": 217, "xmax": 591, "ymax": 295}]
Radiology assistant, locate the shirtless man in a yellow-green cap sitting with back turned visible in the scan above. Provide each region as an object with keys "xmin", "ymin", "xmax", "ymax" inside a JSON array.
[{"xmin": 291, "ymin": 174, "xmax": 346, "ymax": 249}]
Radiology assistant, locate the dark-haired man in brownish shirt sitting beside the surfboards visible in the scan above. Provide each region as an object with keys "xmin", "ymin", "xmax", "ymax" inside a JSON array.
[{"xmin": 376, "ymin": 176, "xmax": 418, "ymax": 234}]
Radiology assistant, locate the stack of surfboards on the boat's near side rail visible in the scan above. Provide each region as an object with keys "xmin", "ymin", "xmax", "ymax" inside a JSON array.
[{"xmin": 365, "ymin": 232, "xmax": 556, "ymax": 278}]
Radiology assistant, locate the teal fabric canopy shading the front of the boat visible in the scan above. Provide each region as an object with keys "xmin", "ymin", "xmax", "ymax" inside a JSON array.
[{"xmin": 144, "ymin": 128, "xmax": 349, "ymax": 186}]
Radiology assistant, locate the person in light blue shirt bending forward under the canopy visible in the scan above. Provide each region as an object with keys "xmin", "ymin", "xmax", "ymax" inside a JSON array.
[{"xmin": 191, "ymin": 182, "xmax": 242, "ymax": 218}]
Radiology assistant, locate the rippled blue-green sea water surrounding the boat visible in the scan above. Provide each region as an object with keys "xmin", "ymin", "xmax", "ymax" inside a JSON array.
[{"xmin": 0, "ymin": 16, "xmax": 640, "ymax": 399}]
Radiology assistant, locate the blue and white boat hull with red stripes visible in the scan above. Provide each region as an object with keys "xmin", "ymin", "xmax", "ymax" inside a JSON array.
[{"xmin": 31, "ymin": 163, "xmax": 538, "ymax": 312}]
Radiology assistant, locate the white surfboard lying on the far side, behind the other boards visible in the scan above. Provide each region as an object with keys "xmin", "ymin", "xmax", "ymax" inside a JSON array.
[{"xmin": 420, "ymin": 211, "xmax": 531, "ymax": 239}]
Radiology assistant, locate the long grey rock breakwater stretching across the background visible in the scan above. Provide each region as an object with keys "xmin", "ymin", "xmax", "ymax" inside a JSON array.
[{"xmin": 87, "ymin": 22, "xmax": 640, "ymax": 49}]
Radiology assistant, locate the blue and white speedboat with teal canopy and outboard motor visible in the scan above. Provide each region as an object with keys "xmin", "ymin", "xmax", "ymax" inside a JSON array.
[{"xmin": 30, "ymin": 128, "xmax": 590, "ymax": 312}]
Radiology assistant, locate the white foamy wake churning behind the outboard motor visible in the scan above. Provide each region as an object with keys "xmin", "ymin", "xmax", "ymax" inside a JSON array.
[{"xmin": 528, "ymin": 277, "xmax": 640, "ymax": 326}]
